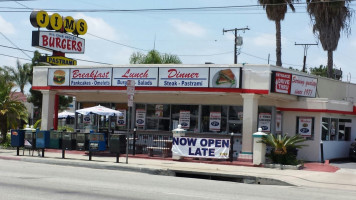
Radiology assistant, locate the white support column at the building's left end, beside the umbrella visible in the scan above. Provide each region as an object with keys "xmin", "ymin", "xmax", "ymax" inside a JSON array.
[{"xmin": 41, "ymin": 91, "xmax": 56, "ymax": 130}]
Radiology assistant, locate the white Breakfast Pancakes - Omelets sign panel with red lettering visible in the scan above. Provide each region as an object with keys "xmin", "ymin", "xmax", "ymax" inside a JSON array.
[{"xmin": 70, "ymin": 68, "xmax": 112, "ymax": 86}]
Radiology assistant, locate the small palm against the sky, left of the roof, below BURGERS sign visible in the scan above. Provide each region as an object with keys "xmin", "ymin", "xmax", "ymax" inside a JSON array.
[{"xmin": 5, "ymin": 60, "xmax": 30, "ymax": 93}]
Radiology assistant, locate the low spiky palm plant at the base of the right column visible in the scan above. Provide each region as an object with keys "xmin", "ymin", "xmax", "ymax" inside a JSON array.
[{"xmin": 260, "ymin": 134, "xmax": 306, "ymax": 165}]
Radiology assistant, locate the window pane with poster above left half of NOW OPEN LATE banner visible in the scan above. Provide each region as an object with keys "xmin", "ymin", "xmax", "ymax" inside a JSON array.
[{"xmin": 171, "ymin": 105, "xmax": 199, "ymax": 132}]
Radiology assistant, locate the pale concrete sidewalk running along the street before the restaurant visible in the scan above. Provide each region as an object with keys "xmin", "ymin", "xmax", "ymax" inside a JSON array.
[{"xmin": 0, "ymin": 149, "xmax": 356, "ymax": 191}]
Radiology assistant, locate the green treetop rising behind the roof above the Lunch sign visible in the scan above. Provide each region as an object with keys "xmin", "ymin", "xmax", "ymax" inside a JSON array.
[{"xmin": 130, "ymin": 50, "xmax": 182, "ymax": 64}]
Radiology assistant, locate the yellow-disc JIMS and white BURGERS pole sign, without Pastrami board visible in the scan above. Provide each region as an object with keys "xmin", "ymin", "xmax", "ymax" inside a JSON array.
[{"xmin": 30, "ymin": 11, "xmax": 88, "ymax": 54}]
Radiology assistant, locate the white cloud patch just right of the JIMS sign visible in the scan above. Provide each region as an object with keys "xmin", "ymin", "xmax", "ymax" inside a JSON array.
[{"xmin": 73, "ymin": 13, "xmax": 117, "ymax": 40}]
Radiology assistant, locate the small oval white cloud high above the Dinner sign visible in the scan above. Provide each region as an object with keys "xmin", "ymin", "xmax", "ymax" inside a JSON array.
[{"xmin": 170, "ymin": 19, "xmax": 206, "ymax": 37}]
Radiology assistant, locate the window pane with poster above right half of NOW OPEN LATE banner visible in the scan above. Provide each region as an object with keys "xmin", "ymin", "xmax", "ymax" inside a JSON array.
[{"xmin": 201, "ymin": 106, "xmax": 227, "ymax": 133}]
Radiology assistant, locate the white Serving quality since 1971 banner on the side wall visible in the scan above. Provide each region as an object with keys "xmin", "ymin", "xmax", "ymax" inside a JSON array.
[{"xmin": 290, "ymin": 75, "xmax": 318, "ymax": 97}]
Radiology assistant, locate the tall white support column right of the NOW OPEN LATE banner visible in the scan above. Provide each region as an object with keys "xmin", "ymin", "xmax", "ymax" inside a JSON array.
[{"xmin": 238, "ymin": 94, "xmax": 260, "ymax": 162}]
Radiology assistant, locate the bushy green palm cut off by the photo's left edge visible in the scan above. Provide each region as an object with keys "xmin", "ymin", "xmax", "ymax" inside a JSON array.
[{"xmin": 0, "ymin": 70, "xmax": 28, "ymax": 144}]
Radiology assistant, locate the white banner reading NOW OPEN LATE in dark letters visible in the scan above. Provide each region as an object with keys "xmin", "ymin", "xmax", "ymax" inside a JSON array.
[{"xmin": 172, "ymin": 137, "xmax": 230, "ymax": 159}]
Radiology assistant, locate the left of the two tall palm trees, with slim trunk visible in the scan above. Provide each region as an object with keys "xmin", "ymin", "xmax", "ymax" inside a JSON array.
[{"xmin": 258, "ymin": 0, "xmax": 298, "ymax": 66}]
